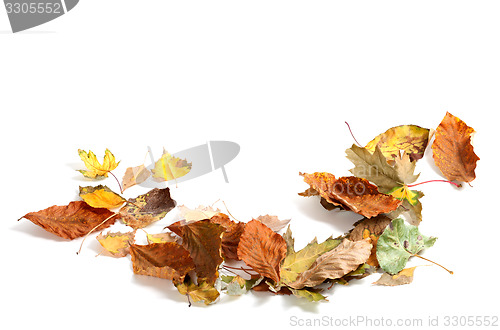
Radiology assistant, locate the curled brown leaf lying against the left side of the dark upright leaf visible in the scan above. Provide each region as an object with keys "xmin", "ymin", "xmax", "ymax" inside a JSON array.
[{"xmin": 130, "ymin": 242, "xmax": 195, "ymax": 284}]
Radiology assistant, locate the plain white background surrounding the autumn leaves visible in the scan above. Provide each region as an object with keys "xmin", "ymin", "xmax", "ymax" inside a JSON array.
[{"xmin": 0, "ymin": 0, "xmax": 500, "ymax": 329}]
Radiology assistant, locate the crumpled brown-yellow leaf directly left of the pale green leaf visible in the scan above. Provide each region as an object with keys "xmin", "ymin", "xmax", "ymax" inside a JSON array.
[{"xmin": 347, "ymin": 214, "xmax": 391, "ymax": 267}]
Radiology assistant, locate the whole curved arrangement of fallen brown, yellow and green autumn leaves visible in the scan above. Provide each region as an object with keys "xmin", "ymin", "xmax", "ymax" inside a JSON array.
[{"xmin": 19, "ymin": 113, "xmax": 479, "ymax": 304}]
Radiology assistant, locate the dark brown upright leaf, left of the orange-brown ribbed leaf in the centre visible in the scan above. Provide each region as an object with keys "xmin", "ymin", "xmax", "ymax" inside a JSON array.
[{"xmin": 168, "ymin": 220, "xmax": 224, "ymax": 284}]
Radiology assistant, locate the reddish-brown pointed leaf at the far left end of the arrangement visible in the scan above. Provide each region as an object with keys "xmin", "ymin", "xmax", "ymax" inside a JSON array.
[{"xmin": 19, "ymin": 201, "xmax": 120, "ymax": 240}]
